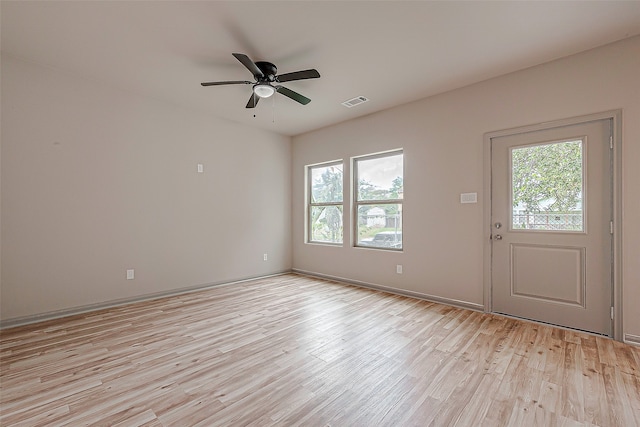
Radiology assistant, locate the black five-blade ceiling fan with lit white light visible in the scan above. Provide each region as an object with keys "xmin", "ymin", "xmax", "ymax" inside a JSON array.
[{"xmin": 200, "ymin": 53, "xmax": 320, "ymax": 108}]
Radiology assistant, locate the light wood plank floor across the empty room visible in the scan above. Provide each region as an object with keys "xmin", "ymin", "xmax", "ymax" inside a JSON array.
[{"xmin": 0, "ymin": 274, "xmax": 640, "ymax": 427}]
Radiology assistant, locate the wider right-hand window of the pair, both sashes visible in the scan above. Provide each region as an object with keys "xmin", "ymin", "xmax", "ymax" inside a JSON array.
[{"xmin": 353, "ymin": 151, "xmax": 404, "ymax": 250}]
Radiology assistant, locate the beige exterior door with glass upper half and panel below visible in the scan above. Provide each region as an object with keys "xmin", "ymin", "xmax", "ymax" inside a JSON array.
[{"xmin": 491, "ymin": 119, "xmax": 613, "ymax": 336}]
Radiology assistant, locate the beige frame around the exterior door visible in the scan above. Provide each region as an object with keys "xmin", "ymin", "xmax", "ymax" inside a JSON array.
[{"xmin": 482, "ymin": 109, "xmax": 623, "ymax": 341}]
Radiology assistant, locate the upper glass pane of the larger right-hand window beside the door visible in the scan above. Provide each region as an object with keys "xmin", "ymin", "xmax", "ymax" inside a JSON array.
[{"xmin": 357, "ymin": 153, "xmax": 404, "ymax": 201}]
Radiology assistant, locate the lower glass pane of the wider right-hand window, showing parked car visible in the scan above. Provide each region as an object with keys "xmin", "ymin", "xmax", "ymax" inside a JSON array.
[{"xmin": 357, "ymin": 204, "xmax": 402, "ymax": 249}]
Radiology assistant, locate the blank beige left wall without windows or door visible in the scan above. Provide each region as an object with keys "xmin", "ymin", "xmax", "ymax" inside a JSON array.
[{"xmin": 1, "ymin": 55, "xmax": 291, "ymax": 320}]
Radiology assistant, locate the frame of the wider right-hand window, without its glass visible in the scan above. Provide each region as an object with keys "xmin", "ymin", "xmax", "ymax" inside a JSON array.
[{"xmin": 351, "ymin": 148, "xmax": 405, "ymax": 252}]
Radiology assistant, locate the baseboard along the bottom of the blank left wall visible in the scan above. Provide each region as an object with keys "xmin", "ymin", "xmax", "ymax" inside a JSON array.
[{"xmin": 0, "ymin": 270, "xmax": 291, "ymax": 330}]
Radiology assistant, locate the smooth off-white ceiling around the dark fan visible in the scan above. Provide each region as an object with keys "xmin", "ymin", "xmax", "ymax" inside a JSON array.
[{"xmin": 0, "ymin": 1, "xmax": 640, "ymax": 135}]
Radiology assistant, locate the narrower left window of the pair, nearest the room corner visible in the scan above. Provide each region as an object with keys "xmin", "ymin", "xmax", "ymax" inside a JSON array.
[{"xmin": 307, "ymin": 161, "xmax": 343, "ymax": 244}]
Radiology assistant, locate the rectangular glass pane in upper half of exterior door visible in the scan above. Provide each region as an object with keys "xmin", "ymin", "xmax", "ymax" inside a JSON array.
[{"xmin": 511, "ymin": 140, "xmax": 584, "ymax": 231}]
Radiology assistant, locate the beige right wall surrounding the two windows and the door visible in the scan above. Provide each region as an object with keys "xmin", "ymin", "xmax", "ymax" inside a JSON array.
[{"xmin": 292, "ymin": 37, "xmax": 640, "ymax": 342}]
